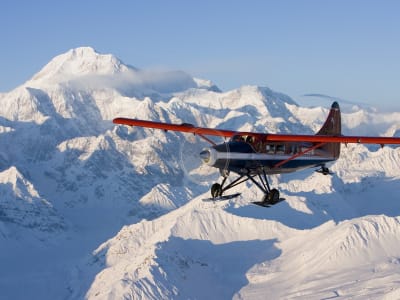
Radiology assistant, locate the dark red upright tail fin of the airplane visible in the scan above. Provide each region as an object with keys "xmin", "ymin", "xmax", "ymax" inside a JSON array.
[{"xmin": 316, "ymin": 101, "xmax": 342, "ymax": 158}]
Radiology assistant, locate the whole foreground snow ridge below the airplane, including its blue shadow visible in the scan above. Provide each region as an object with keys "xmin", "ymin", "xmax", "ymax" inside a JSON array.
[{"xmin": 81, "ymin": 199, "xmax": 400, "ymax": 299}]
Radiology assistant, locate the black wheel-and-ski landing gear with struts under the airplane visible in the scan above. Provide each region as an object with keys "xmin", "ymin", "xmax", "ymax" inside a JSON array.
[{"xmin": 204, "ymin": 170, "xmax": 285, "ymax": 207}]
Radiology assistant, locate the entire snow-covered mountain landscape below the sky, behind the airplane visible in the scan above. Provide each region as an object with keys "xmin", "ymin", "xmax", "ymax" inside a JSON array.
[{"xmin": 0, "ymin": 47, "xmax": 400, "ymax": 299}]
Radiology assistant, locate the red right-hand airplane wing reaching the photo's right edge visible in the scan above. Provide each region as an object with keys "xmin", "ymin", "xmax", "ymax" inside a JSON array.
[{"xmin": 265, "ymin": 134, "xmax": 400, "ymax": 145}]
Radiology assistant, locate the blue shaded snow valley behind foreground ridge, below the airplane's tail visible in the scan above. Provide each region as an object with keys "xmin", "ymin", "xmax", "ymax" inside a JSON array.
[{"xmin": 226, "ymin": 175, "xmax": 400, "ymax": 230}]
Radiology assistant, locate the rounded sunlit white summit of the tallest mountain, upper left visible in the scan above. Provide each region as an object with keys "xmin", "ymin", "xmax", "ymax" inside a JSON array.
[{"xmin": 30, "ymin": 47, "xmax": 129, "ymax": 82}]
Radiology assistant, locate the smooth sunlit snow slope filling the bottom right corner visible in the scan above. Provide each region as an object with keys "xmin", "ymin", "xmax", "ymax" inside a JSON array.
[{"xmin": 240, "ymin": 216, "xmax": 400, "ymax": 299}]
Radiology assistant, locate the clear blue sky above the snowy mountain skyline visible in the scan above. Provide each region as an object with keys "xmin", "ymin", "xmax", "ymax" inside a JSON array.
[{"xmin": 0, "ymin": 0, "xmax": 400, "ymax": 109}]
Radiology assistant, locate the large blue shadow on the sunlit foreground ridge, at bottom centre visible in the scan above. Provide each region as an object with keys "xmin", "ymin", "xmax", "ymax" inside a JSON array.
[{"xmin": 152, "ymin": 237, "xmax": 281, "ymax": 299}]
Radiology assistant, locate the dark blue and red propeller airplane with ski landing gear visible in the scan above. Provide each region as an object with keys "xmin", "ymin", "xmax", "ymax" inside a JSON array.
[{"xmin": 113, "ymin": 101, "xmax": 400, "ymax": 207}]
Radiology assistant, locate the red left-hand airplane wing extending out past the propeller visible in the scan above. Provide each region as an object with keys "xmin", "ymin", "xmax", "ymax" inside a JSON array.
[{"xmin": 113, "ymin": 118, "xmax": 237, "ymax": 137}]
